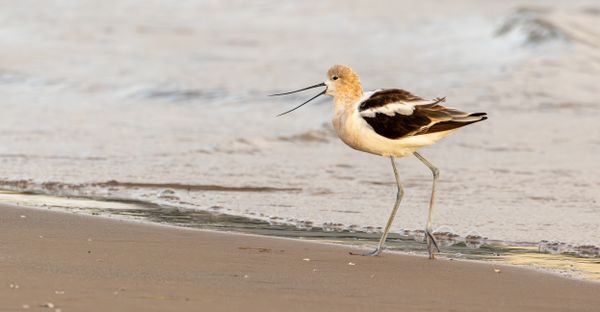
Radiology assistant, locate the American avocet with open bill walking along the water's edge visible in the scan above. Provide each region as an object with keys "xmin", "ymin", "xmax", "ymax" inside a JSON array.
[{"xmin": 273, "ymin": 65, "xmax": 487, "ymax": 259}]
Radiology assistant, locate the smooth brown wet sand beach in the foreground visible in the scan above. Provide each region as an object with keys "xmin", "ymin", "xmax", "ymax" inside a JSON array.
[{"xmin": 0, "ymin": 205, "xmax": 600, "ymax": 312}]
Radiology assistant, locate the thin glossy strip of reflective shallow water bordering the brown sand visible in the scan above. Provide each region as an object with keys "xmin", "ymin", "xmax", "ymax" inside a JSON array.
[{"xmin": 0, "ymin": 191, "xmax": 600, "ymax": 281}]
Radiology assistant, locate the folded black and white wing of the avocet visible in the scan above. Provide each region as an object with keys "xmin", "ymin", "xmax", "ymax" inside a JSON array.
[{"xmin": 358, "ymin": 89, "xmax": 487, "ymax": 139}]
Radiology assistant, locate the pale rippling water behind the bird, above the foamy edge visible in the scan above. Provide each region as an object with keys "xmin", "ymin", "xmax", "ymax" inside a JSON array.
[{"xmin": 0, "ymin": 0, "xmax": 600, "ymax": 258}]
